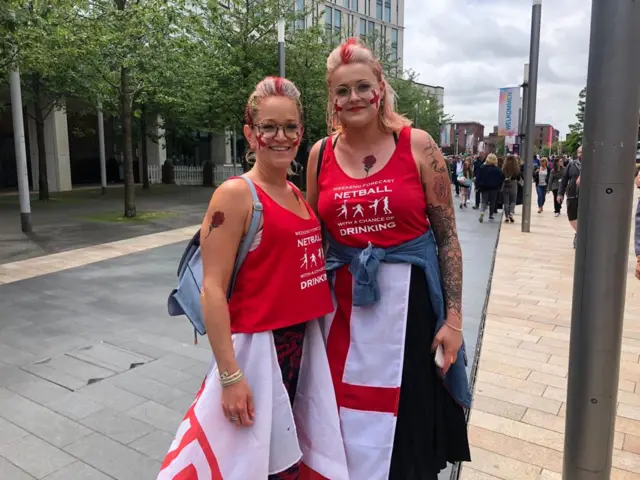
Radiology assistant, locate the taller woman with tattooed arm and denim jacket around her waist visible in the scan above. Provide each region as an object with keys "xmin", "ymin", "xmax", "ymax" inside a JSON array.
[{"xmin": 307, "ymin": 39, "xmax": 471, "ymax": 480}]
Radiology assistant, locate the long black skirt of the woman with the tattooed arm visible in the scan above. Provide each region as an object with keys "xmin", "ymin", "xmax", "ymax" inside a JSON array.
[{"xmin": 389, "ymin": 266, "xmax": 471, "ymax": 480}]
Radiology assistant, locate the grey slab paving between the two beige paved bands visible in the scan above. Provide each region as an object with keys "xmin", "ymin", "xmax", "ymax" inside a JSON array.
[{"xmin": 0, "ymin": 202, "xmax": 499, "ymax": 480}]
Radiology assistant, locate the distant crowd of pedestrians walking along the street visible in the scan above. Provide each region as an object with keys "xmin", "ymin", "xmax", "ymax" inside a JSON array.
[{"xmin": 447, "ymin": 147, "xmax": 582, "ymax": 248}]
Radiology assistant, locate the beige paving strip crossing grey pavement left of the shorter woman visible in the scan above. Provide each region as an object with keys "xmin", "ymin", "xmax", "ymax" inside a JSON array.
[{"xmin": 0, "ymin": 225, "xmax": 200, "ymax": 285}]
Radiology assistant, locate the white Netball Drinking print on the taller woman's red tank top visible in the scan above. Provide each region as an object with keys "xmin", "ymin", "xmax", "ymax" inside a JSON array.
[{"xmin": 332, "ymin": 178, "xmax": 396, "ymax": 237}]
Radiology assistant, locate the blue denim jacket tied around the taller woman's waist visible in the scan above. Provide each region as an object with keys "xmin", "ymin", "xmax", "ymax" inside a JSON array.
[{"xmin": 325, "ymin": 230, "xmax": 471, "ymax": 408}]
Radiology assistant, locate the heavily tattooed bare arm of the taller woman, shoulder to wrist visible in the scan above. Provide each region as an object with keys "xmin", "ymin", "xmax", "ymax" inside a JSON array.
[{"xmin": 412, "ymin": 129, "xmax": 462, "ymax": 328}]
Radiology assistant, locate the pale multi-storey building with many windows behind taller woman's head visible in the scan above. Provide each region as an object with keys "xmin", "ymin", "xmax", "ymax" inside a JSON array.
[{"xmin": 296, "ymin": 0, "xmax": 405, "ymax": 71}]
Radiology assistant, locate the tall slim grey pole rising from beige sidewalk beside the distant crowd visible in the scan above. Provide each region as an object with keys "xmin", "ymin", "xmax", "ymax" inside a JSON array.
[{"xmin": 521, "ymin": 0, "xmax": 542, "ymax": 232}]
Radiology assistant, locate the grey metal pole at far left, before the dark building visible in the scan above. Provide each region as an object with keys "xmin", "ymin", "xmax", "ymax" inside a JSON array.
[{"xmin": 9, "ymin": 67, "xmax": 33, "ymax": 233}]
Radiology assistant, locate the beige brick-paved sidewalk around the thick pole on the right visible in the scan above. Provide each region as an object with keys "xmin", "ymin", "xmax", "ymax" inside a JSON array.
[{"xmin": 461, "ymin": 198, "xmax": 640, "ymax": 480}]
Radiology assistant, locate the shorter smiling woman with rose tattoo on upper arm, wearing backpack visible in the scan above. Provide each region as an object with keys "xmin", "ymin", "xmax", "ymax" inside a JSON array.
[{"xmin": 158, "ymin": 77, "xmax": 346, "ymax": 480}]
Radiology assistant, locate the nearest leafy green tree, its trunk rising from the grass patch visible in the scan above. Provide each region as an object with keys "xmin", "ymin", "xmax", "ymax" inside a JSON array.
[{"xmin": 73, "ymin": 0, "xmax": 203, "ymax": 217}]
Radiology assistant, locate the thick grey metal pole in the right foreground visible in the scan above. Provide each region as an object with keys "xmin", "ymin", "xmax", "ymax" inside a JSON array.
[{"xmin": 563, "ymin": 0, "xmax": 640, "ymax": 480}]
